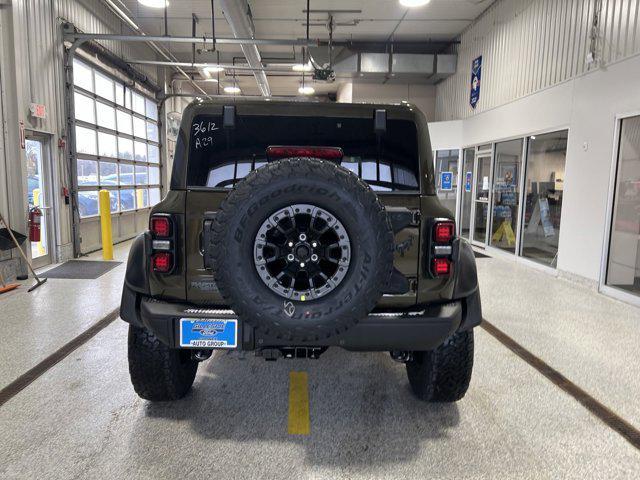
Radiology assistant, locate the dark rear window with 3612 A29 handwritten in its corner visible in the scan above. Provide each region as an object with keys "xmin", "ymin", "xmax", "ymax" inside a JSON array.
[{"xmin": 187, "ymin": 115, "xmax": 419, "ymax": 191}]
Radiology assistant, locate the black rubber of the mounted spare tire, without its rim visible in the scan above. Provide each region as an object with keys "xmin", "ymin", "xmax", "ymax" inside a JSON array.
[{"xmin": 212, "ymin": 158, "xmax": 394, "ymax": 343}]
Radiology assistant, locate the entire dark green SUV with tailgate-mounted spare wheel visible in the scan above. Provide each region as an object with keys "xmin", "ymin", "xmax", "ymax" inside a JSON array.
[{"xmin": 120, "ymin": 98, "xmax": 482, "ymax": 402}]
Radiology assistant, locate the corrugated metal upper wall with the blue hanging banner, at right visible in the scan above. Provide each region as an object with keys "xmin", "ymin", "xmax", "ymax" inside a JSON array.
[{"xmin": 436, "ymin": 0, "xmax": 640, "ymax": 120}]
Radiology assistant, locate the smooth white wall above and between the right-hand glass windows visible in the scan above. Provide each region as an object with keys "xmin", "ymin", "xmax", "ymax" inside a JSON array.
[{"xmin": 429, "ymin": 51, "xmax": 640, "ymax": 281}]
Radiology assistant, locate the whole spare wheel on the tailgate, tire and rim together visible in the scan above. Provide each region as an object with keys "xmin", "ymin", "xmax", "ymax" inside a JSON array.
[{"xmin": 212, "ymin": 158, "xmax": 394, "ymax": 342}]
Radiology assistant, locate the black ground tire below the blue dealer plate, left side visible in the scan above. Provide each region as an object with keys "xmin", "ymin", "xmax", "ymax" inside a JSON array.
[{"xmin": 128, "ymin": 325, "xmax": 198, "ymax": 402}]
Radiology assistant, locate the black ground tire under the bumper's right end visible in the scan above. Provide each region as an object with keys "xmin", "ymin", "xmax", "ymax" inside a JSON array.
[{"xmin": 406, "ymin": 330, "xmax": 473, "ymax": 402}]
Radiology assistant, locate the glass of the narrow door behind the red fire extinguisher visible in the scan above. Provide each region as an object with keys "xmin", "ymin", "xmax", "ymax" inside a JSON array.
[{"xmin": 25, "ymin": 137, "xmax": 52, "ymax": 268}]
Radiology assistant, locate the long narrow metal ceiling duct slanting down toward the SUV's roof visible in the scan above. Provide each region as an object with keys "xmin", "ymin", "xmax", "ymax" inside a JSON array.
[{"xmin": 220, "ymin": 0, "xmax": 271, "ymax": 97}]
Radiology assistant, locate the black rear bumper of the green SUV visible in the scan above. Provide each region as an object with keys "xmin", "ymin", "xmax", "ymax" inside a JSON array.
[{"xmin": 121, "ymin": 287, "xmax": 480, "ymax": 351}]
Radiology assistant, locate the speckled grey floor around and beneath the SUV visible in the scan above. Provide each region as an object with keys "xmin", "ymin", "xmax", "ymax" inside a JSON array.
[{"xmin": 0, "ymin": 248, "xmax": 640, "ymax": 479}]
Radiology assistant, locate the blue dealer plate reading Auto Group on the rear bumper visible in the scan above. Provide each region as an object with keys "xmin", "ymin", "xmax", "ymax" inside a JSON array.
[{"xmin": 178, "ymin": 317, "xmax": 238, "ymax": 349}]
